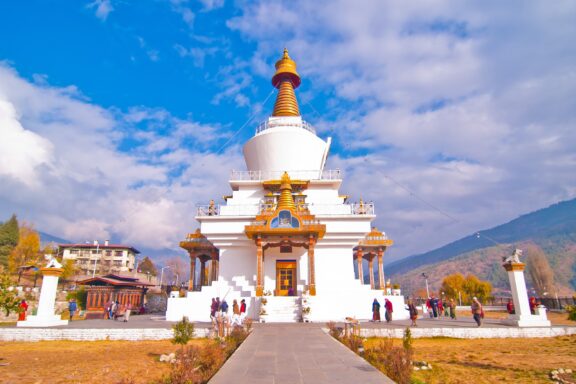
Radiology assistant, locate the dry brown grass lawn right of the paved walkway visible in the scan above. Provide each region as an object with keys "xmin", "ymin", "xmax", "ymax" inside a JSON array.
[{"xmin": 367, "ymin": 336, "xmax": 576, "ymax": 384}]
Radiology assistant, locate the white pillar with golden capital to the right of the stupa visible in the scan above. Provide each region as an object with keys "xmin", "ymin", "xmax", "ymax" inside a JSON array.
[{"xmin": 504, "ymin": 262, "xmax": 551, "ymax": 327}]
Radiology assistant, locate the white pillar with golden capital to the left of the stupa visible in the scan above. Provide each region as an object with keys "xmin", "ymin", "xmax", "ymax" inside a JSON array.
[{"xmin": 16, "ymin": 268, "xmax": 68, "ymax": 327}]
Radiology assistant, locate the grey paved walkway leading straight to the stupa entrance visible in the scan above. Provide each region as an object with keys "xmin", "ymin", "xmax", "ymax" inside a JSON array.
[{"xmin": 210, "ymin": 324, "xmax": 393, "ymax": 384}]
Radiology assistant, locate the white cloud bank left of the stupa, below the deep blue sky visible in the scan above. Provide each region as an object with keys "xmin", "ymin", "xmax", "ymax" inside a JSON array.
[{"xmin": 0, "ymin": 65, "xmax": 241, "ymax": 250}]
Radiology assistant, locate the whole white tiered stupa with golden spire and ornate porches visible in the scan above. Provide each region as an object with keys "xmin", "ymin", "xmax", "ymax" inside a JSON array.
[{"xmin": 166, "ymin": 50, "xmax": 408, "ymax": 322}]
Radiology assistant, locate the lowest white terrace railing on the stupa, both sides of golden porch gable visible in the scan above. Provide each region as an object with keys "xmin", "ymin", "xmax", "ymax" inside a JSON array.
[{"xmin": 196, "ymin": 203, "xmax": 375, "ymax": 216}]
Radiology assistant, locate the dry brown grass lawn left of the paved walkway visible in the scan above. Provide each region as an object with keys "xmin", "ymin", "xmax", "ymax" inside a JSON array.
[{"xmin": 0, "ymin": 340, "xmax": 205, "ymax": 384}]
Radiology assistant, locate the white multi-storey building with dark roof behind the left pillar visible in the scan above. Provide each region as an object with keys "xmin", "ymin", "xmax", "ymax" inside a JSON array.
[{"xmin": 58, "ymin": 240, "xmax": 140, "ymax": 275}]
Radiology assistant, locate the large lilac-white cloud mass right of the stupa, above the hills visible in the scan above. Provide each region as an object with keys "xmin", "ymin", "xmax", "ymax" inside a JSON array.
[{"xmin": 227, "ymin": 0, "xmax": 576, "ymax": 257}]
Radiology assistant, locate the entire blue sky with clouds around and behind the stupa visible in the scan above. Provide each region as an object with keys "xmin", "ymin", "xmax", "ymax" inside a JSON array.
[{"xmin": 0, "ymin": 0, "xmax": 576, "ymax": 259}]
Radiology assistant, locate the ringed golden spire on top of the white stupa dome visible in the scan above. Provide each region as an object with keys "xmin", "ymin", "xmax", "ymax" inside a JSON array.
[{"xmin": 272, "ymin": 48, "xmax": 300, "ymax": 116}]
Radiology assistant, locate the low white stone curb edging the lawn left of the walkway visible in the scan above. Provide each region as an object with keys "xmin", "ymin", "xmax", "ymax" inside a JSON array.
[{"xmin": 0, "ymin": 328, "xmax": 210, "ymax": 341}]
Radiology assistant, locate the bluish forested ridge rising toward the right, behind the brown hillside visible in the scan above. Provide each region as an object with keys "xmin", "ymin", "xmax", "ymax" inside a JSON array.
[{"xmin": 386, "ymin": 199, "xmax": 576, "ymax": 275}]
